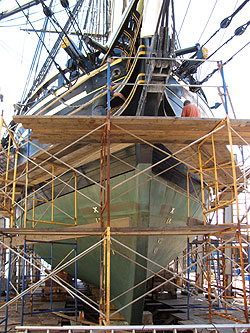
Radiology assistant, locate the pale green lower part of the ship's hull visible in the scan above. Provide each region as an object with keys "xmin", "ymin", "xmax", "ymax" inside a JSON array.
[{"xmin": 23, "ymin": 156, "xmax": 202, "ymax": 324}]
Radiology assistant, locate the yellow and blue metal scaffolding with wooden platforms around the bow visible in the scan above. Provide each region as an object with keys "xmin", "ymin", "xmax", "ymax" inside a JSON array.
[{"xmin": 0, "ymin": 62, "xmax": 250, "ymax": 326}]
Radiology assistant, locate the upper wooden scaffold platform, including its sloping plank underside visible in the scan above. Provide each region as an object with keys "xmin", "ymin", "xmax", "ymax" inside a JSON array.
[{"xmin": 9, "ymin": 116, "xmax": 246, "ymax": 193}]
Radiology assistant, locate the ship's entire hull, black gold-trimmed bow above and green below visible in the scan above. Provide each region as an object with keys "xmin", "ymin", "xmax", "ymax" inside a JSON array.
[{"xmin": 14, "ymin": 50, "xmax": 207, "ymax": 324}]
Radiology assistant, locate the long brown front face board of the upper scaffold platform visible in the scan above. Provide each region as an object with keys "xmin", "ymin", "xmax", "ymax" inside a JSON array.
[{"xmin": 14, "ymin": 116, "xmax": 250, "ymax": 144}]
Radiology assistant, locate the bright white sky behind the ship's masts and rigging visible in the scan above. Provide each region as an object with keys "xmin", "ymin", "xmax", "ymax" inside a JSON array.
[{"xmin": 0, "ymin": 0, "xmax": 250, "ymax": 119}]
